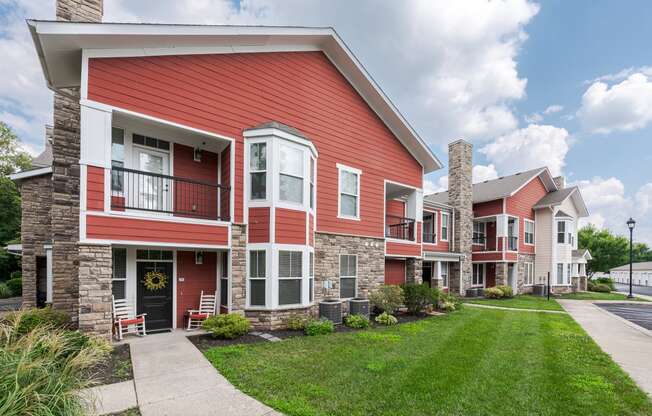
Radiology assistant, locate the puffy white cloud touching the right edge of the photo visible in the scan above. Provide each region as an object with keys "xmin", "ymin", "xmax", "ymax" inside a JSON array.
[{"xmin": 577, "ymin": 72, "xmax": 652, "ymax": 133}]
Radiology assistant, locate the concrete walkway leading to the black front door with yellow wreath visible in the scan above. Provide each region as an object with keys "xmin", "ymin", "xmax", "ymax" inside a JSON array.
[{"xmin": 92, "ymin": 330, "xmax": 281, "ymax": 416}]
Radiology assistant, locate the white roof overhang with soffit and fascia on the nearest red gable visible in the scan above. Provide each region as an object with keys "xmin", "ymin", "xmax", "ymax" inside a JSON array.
[{"xmin": 27, "ymin": 20, "xmax": 442, "ymax": 173}]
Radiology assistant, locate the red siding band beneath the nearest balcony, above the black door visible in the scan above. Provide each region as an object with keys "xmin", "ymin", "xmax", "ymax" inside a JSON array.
[{"xmin": 86, "ymin": 215, "xmax": 229, "ymax": 246}]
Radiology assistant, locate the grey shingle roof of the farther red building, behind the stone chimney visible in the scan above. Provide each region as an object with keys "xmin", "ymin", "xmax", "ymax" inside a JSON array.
[{"xmin": 424, "ymin": 168, "xmax": 557, "ymax": 204}]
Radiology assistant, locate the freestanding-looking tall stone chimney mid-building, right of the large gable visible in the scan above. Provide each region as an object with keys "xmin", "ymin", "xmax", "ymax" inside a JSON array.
[{"xmin": 448, "ymin": 139, "xmax": 473, "ymax": 295}]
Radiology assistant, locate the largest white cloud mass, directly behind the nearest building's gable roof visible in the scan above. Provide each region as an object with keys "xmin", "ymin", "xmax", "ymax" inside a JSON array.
[{"xmin": 0, "ymin": 0, "xmax": 539, "ymax": 154}]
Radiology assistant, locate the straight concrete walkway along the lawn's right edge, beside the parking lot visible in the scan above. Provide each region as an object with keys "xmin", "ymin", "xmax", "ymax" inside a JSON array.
[{"xmin": 558, "ymin": 299, "xmax": 652, "ymax": 397}]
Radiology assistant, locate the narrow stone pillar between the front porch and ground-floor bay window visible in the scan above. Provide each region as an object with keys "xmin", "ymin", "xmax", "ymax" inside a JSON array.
[{"xmin": 229, "ymin": 224, "xmax": 247, "ymax": 314}]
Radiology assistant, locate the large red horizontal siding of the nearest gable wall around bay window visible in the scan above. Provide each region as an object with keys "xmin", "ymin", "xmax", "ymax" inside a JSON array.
[{"xmin": 88, "ymin": 52, "xmax": 422, "ymax": 237}]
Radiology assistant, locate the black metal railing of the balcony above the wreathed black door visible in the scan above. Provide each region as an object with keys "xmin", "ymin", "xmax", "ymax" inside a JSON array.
[{"xmin": 111, "ymin": 166, "xmax": 230, "ymax": 221}]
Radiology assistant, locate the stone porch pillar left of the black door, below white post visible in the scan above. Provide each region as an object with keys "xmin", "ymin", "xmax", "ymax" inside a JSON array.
[{"xmin": 79, "ymin": 244, "xmax": 113, "ymax": 339}]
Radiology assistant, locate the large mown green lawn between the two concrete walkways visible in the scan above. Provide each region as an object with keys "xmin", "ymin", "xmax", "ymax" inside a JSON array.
[{"xmin": 206, "ymin": 308, "xmax": 652, "ymax": 416}]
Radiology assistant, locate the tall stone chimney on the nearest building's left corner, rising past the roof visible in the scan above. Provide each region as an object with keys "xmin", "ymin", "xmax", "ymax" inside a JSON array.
[{"xmin": 51, "ymin": 0, "xmax": 102, "ymax": 322}]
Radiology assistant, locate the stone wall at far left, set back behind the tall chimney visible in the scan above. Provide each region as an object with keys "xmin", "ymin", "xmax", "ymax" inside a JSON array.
[{"xmin": 20, "ymin": 174, "xmax": 52, "ymax": 308}]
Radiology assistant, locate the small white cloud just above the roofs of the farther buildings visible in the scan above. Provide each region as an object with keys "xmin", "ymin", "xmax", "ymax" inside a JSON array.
[{"xmin": 479, "ymin": 124, "xmax": 571, "ymax": 175}]
